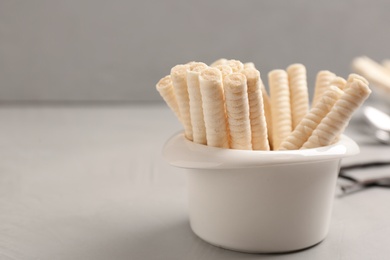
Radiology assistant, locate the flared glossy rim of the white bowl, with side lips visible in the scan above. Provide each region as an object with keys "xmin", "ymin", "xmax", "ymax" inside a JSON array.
[{"xmin": 163, "ymin": 131, "xmax": 359, "ymax": 169}]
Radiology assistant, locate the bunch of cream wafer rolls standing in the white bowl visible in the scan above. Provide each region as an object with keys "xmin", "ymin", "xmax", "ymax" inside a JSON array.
[{"xmin": 156, "ymin": 59, "xmax": 372, "ymax": 151}]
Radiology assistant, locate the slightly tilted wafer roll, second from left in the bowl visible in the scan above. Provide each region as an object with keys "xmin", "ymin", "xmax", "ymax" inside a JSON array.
[{"xmin": 171, "ymin": 65, "xmax": 193, "ymax": 141}]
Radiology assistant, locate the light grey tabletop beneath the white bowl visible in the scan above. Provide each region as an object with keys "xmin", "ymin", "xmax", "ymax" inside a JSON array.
[{"xmin": 0, "ymin": 105, "xmax": 390, "ymax": 260}]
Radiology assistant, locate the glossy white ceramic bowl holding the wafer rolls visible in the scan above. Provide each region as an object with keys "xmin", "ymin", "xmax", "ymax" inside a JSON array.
[{"xmin": 163, "ymin": 133, "xmax": 359, "ymax": 253}]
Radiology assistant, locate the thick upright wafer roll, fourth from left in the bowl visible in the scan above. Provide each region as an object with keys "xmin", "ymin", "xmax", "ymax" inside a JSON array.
[{"xmin": 199, "ymin": 68, "xmax": 229, "ymax": 148}]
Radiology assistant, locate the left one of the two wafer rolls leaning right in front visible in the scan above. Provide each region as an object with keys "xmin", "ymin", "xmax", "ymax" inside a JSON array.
[{"xmin": 279, "ymin": 86, "xmax": 343, "ymax": 150}]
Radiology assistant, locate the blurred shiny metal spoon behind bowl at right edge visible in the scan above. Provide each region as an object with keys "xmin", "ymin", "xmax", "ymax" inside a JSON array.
[{"xmin": 363, "ymin": 106, "xmax": 390, "ymax": 144}]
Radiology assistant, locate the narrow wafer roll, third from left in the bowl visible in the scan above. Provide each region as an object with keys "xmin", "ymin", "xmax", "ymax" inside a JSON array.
[{"xmin": 187, "ymin": 62, "xmax": 208, "ymax": 144}]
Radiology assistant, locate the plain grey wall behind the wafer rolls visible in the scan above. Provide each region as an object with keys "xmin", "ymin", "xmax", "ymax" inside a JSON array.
[{"xmin": 0, "ymin": 0, "xmax": 390, "ymax": 101}]
